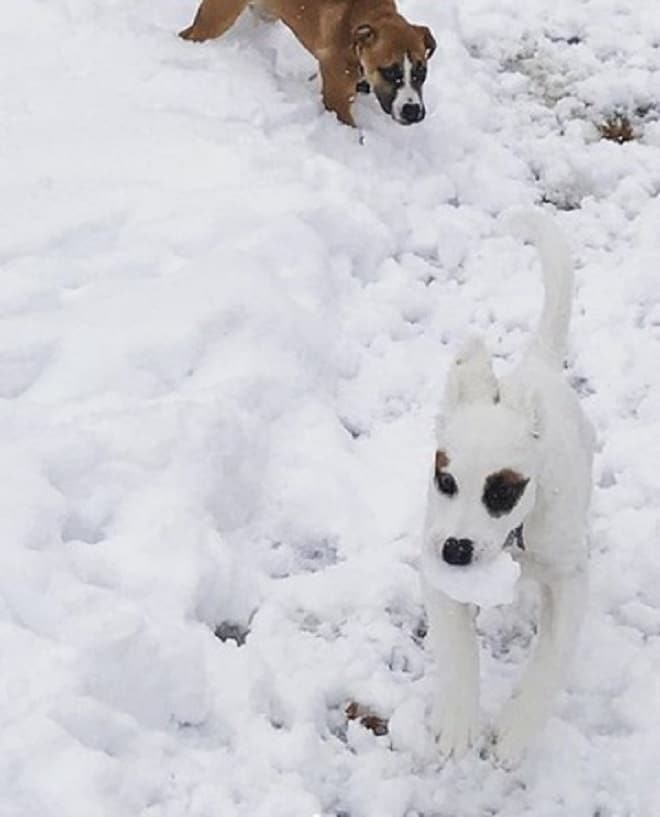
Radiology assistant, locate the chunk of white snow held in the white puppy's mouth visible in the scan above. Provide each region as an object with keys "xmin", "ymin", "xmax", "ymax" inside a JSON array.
[{"xmin": 421, "ymin": 550, "xmax": 520, "ymax": 608}]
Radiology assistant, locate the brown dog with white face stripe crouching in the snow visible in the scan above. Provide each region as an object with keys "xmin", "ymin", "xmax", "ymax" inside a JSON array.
[{"xmin": 181, "ymin": 0, "xmax": 435, "ymax": 125}]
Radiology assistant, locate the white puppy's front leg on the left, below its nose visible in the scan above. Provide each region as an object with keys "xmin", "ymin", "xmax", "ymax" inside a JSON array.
[{"xmin": 424, "ymin": 585, "xmax": 479, "ymax": 758}]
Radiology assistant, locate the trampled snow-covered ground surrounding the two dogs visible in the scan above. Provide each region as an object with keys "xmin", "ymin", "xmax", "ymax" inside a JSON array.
[{"xmin": 0, "ymin": 0, "xmax": 660, "ymax": 817}]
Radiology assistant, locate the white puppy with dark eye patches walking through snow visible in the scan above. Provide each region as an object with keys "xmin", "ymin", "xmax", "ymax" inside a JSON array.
[{"xmin": 422, "ymin": 214, "xmax": 594, "ymax": 766}]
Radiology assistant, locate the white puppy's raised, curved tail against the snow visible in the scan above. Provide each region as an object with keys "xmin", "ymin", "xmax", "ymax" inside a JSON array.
[{"xmin": 511, "ymin": 211, "xmax": 574, "ymax": 368}]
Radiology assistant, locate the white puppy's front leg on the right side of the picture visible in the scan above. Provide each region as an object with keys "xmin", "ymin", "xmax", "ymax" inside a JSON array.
[{"xmin": 494, "ymin": 570, "xmax": 587, "ymax": 768}]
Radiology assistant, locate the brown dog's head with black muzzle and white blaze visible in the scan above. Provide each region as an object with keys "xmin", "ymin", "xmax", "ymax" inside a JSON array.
[{"xmin": 353, "ymin": 15, "xmax": 435, "ymax": 125}]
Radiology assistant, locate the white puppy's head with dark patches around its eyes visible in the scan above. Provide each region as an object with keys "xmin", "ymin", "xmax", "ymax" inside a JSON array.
[{"xmin": 425, "ymin": 341, "xmax": 542, "ymax": 565}]
